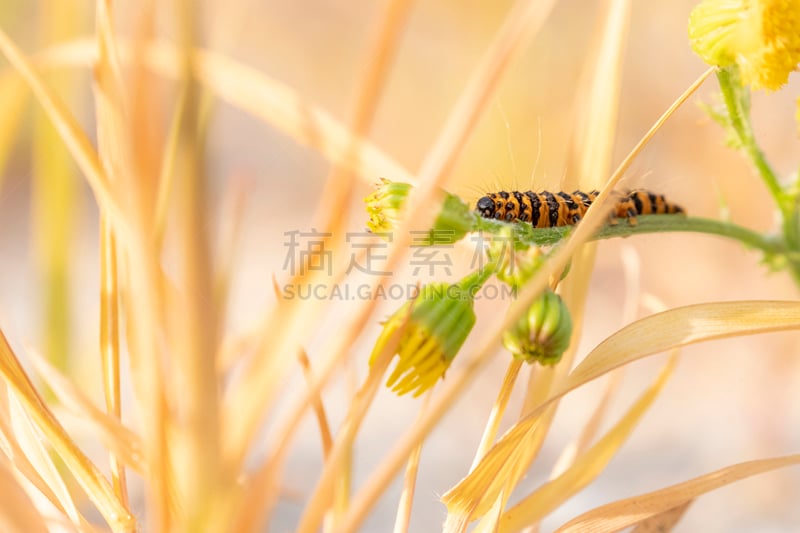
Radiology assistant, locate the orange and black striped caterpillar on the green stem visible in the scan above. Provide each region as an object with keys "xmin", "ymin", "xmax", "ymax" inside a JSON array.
[{"xmin": 476, "ymin": 189, "xmax": 684, "ymax": 228}]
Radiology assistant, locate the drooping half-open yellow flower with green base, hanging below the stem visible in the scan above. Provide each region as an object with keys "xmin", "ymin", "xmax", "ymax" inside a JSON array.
[{"xmin": 370, "ymin": 276, "xmax": 485, "ymax": 397}]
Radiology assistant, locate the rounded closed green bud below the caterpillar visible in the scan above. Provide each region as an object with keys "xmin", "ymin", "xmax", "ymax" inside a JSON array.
[{"xmin": 503, "ymin": 290, "xmax": 572, "ymax": 365}]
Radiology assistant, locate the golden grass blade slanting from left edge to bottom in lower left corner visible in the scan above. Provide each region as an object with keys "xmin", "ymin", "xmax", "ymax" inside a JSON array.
[{"xmin": 0, "ymin": 332, "xmax": 136, "ymax": 531}]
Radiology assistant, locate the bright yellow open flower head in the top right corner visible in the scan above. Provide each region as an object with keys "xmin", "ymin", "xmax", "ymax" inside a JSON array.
[{"xmin": 689, "ymin": 0, "xmax": 800, "ymax": 90}]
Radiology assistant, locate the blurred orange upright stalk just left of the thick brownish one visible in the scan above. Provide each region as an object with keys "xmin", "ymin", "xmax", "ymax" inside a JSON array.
[{"xmin": 109, "ymin": 11, "xmax": 175, "ymax": 531}]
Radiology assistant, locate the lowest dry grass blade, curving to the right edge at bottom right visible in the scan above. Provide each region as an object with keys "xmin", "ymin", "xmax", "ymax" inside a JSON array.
[{"xmin": 557, "ymin": 455, "xmax": 800, "ymax": 533}]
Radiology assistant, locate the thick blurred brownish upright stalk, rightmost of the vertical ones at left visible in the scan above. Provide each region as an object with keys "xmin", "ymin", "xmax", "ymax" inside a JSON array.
[{"xmin": 168, "ymin": 0, "xmax": 227, "ymax": 531}]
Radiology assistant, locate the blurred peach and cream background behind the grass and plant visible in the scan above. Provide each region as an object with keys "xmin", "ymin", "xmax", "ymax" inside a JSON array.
[{"xmin": 0, "ymin": 0, "xmax": 800, "ymax": 532}]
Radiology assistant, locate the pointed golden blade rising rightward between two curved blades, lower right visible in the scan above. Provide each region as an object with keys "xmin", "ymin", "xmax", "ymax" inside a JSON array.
[{"xmin": 499, "ymin": 354, "xmax": 677, "ymax": 531}]
